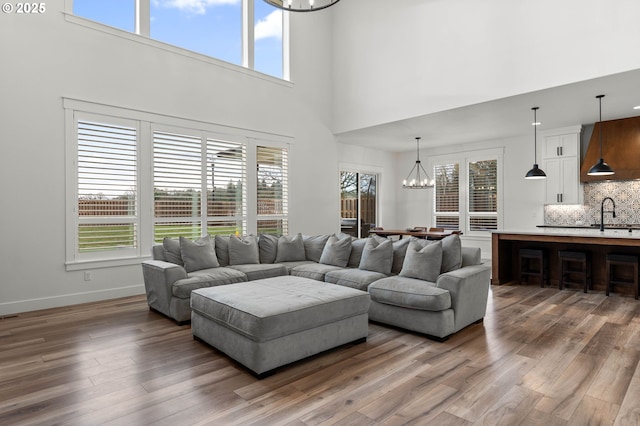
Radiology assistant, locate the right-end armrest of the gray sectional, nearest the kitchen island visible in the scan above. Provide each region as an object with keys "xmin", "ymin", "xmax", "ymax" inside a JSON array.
[{"xmin": 436, "ymin": 265, "xmax": 491, "ymax": 331}]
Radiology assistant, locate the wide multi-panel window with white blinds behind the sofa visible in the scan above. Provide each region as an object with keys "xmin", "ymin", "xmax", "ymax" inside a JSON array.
[{"xmin": 64, "ymin": 99, "xmax": 289, "ymax": 270}]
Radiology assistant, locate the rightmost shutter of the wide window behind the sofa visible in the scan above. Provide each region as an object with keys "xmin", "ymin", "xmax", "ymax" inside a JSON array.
[{"xmin": 256, "ymin": 146, "xmax": 289, "ymax": 234}]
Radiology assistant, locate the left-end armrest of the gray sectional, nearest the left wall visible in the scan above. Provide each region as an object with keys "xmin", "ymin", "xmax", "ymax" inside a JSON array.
[{"xmin": 142, "ymin": 260, "xmax": 187, "ymax": 316}]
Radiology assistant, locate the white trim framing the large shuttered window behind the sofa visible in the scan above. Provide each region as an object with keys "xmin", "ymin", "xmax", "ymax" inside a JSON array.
[{"xmin": 62, "ymin": 98, "xmax": 295, "ymax": 271}]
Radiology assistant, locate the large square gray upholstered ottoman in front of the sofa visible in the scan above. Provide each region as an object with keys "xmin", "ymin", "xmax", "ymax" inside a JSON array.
[{"xmin": 191, "ymin": 276, "xmax": 370, "ymax": 377}]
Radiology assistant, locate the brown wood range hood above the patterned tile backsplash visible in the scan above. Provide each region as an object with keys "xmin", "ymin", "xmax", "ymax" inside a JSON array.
[{"xmin": 580, "ymin": 117, "xmax": 640, "ymax": 182}]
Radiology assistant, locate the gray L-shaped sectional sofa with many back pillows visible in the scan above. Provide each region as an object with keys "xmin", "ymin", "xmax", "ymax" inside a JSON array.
[{"xmin": 142, "ymin": 234, "xmax": 491, "ymax": 340}]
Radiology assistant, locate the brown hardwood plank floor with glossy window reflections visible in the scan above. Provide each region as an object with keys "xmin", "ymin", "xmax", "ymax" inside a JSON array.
[{"xmin": 0, "ymin": 286, "xmax": 640, "ymax": 426}]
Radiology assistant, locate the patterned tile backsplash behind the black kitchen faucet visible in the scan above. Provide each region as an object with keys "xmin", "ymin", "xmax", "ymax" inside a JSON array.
[{"xmin": 544, "ymin": 180, "xmax": 640, "ymax": 226}]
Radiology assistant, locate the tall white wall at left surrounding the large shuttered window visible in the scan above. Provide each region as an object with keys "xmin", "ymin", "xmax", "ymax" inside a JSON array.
[{"xmin": 0, "ymin": 0, "xmax": 339, "ymax": 315}]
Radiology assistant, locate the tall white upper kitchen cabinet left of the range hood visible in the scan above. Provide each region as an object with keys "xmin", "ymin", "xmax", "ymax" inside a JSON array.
[{"xmin": 542, "ymin": 127, "xmax": 583, "ymax": 204}]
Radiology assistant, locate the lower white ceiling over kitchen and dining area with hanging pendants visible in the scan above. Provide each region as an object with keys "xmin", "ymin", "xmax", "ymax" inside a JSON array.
[{"xmin": 337, "ymin": 70, "xmax": 640, "ymax": 152}]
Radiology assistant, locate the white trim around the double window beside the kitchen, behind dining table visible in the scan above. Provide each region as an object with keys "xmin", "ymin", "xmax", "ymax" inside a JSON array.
[{"xmin": 428, "ymin": 148, "xmax": 504, "ymax": 239}]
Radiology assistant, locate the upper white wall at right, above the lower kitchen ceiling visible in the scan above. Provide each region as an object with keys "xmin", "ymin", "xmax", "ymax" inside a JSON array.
[{"xmin": 333, "ymin": 0, "xmax": 640, "ymax": 133}]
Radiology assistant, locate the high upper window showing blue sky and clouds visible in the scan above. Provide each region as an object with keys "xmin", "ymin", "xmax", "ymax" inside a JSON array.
[{"xmin": 68, "ymin": 0, "xmax": 288, "ymax": 78}]
